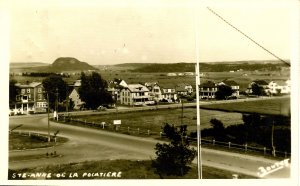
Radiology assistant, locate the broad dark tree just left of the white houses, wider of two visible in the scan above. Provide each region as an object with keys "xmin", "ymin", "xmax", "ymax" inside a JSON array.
[{"xmin": 78, "ymin": 72, "xmax": 113, "ymax": 109}]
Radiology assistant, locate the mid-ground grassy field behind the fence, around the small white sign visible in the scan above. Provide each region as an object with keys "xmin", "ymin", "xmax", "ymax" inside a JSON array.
[{"xmin": 67, "ymin": 108, "xmax": 242, "ymax": 133}]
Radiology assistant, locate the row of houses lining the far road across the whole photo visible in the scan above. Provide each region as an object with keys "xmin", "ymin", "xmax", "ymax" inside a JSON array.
[{"xmin": 10, "ymin": 79, "xmax": 291, "ymax": 114}]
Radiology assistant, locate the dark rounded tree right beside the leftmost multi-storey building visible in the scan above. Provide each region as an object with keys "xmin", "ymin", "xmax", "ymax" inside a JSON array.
[{"xmin": 42, "ymin": 74, "xmax": 67, "ymax": 109}]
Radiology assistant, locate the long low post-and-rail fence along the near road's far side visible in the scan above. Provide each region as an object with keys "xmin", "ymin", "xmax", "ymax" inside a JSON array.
[{"xmin": 56, "ymin": 116, "xmax": 291, "ymax": 158}]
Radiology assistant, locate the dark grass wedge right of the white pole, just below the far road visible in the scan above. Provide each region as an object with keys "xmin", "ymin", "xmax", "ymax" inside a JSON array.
[{"xmin": 201, "ymin": 97, "xmax": 290, "ymax": 116}]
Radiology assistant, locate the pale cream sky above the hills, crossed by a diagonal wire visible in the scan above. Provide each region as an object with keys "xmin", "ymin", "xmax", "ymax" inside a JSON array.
[{"xmin": 9, "ymin": 0, "xmax": 292, "ymax": 65}]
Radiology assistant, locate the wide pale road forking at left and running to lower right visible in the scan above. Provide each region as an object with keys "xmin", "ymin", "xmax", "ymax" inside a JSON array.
[{"xmin": 9, "ymin": 115, "xmax": 290, "ymax": 178}]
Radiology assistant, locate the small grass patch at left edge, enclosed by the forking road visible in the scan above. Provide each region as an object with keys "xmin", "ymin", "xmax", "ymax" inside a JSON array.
[{"xmin": 9, "ymin": 133, "xmax": 67, "ymax": 150}]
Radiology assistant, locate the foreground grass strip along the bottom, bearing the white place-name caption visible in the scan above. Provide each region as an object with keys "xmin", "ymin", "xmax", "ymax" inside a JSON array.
[{"xmin": 8, "ymin": 160, "xmax": 254, "ymax": 180}]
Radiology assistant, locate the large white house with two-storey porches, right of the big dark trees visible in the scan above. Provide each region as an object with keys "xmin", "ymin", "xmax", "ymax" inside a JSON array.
[{"xmin": 120, "ymin": 84, "xmax": 150, "ymax": 106}]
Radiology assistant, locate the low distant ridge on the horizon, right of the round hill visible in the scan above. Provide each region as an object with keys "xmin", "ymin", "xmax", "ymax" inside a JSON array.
[{"xmin": 131, "ymin": 62, "xmax": 288, "ymax": 72}]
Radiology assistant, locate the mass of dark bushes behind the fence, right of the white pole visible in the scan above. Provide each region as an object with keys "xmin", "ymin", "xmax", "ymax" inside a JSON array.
[{"xmin": 202, "ymin": 114, "xmax": 291, "ymax": 152}]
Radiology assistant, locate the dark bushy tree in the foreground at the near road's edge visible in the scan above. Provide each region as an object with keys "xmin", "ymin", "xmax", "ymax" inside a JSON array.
[{"xmin": 152, "ymin": 123, "xmax": 196, "ymax": 177}]
